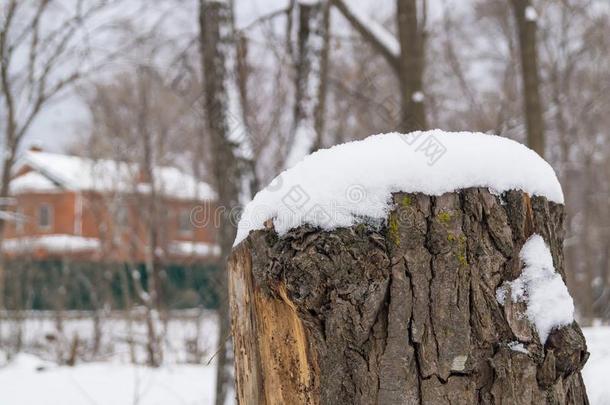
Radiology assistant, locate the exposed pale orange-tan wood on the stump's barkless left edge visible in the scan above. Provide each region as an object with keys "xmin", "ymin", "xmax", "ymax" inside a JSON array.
[{"xmin": 229, "ymin": 244, "xmax": 318, "ymax": 405}]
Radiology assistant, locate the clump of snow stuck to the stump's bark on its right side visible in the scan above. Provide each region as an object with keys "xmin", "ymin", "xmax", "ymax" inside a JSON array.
[{"xmin": 496, "ymin": 234, "xmax": 574, "ymax": 344}]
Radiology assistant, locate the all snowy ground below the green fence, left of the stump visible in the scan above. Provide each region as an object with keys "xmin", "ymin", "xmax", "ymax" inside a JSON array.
[{"xmin": 0, "ymin": 310, "xmax": 217, "ymax": 405}]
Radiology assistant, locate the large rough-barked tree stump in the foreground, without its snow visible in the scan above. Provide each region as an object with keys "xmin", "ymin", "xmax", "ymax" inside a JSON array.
[{"xmin": 229, "ymin": 188, "xmax": 588, "ymax": 405}]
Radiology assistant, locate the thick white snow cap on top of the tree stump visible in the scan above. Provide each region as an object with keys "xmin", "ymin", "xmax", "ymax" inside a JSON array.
[{"xmin": 235, "ymin": 130, "xmax": 563, "ymax": 244}]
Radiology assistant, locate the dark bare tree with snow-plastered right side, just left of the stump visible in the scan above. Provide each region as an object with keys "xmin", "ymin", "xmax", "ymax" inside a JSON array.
[{"xmin": 199, "ymin": 0, "xmax": 255, "ymax": 405}]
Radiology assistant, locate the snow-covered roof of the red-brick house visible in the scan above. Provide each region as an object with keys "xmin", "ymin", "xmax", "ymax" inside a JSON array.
[{"xmin": 11, "ymin": 150, "xmax": 216, "ymax": 200}]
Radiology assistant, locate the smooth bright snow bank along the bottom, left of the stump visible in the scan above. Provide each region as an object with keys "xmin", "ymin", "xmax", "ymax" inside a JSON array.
[{"xmin": 0, "ymin": 354, "xmax": 215, "ymax": 405}]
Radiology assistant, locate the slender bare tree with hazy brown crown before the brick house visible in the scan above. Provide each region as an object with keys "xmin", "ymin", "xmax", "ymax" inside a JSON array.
[{"xmin": 87, "ymin": 64, "xmax": 193, "ymax": 366}]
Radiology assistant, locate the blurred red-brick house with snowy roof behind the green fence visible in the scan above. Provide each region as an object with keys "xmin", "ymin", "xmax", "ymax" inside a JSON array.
[{"xmin": 3, "ymin": 149, "xmax": 219, "ymax": 263}]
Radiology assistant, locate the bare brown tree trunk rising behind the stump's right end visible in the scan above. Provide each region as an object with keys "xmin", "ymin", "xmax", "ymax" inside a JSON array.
[{"xmin": 511, "ymin": 0, "xmax": 544, "ymax": 157}]
